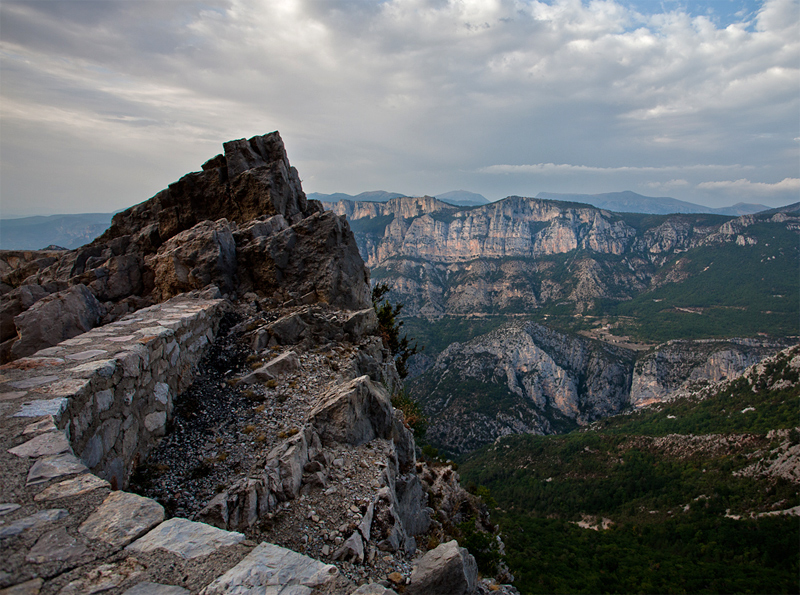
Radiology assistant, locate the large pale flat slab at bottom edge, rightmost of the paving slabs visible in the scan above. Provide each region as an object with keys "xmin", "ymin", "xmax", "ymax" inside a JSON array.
[{"xmin": 200, "ymin": 543, "xmax": 339, "ymax": 595}]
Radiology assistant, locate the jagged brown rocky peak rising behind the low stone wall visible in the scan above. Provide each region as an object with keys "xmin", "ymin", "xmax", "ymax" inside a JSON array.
[{"xmin": 0, "ymin": 132, "xmax": 371, "ymax": 361}]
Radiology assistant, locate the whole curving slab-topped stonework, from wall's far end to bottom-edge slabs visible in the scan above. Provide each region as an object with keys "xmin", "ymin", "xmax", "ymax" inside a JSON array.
[{"xmin": 0, "ymin": 297, "xmax": 351, "ymax": 595}]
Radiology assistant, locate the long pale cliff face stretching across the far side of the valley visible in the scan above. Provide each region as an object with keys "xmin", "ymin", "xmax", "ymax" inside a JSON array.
[{"xmin": 328, "ymin": 197, "xmax": 800, "ymax": 317}]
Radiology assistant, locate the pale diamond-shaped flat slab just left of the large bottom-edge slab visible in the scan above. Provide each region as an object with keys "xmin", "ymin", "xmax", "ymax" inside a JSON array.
[{"xmin": 125, "ymin": 518, "xmax": 244, "ymax": 560}]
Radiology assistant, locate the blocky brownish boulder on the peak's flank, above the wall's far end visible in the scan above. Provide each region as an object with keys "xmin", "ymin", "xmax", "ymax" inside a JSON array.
[{"xmin": 148, "ymin": 219, "xmax": 237, "ymax": 300}]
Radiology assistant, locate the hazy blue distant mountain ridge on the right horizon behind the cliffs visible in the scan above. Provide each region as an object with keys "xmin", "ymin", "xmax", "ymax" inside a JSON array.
[{"xmin": 536, "ymin": 190, "xmax": 769, "ymax": 217}]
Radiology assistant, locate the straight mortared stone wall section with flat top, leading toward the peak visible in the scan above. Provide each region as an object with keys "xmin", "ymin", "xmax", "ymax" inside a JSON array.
[{"xmin": 0, "ymin": 296, "xmax": 224, "ymax": 488}]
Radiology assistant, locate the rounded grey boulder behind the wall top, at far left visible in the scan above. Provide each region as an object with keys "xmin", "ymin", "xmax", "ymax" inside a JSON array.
[{"xmin": 11, "ymin": 285, "xmax": 103, "ymax": 358}]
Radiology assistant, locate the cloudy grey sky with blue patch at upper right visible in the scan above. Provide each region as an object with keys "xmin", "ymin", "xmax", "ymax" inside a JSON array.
[{"xmin": 0, "ymin": 0, "xmax": 800, "ymax": 217}]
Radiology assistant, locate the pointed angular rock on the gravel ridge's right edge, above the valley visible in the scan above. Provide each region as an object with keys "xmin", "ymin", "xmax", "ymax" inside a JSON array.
[{"xmin": 309, "ymin": 376, "xmax": 394, "ymax": 445}]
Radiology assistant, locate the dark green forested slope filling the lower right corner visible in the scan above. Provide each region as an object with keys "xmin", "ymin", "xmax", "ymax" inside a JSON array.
[{"xmin": 460, "ymin": 349, "xmax": 800, "ymax": 593}]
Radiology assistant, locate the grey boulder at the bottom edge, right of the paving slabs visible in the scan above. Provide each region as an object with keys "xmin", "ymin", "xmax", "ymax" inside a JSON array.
[{"xmin": 405, "ymin": 540, "xmax": 478, "ymax": 595}]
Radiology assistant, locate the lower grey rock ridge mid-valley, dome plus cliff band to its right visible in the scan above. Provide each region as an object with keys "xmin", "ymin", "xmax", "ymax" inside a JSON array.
[{"xmin": 409, "ymin": 322, "xmax": 794, "ymax": 453}]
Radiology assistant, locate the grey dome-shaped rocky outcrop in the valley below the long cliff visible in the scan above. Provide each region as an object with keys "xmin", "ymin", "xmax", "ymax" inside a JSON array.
[{"xmin": 410, "ymin": 323, "xmax": 633, "ymax": 452}]
